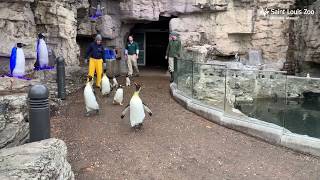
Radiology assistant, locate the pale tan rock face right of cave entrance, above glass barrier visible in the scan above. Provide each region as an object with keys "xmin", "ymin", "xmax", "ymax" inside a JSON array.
[{"xmin": 170, "ymin": 0, "xmax": 294, "ymax": 69}]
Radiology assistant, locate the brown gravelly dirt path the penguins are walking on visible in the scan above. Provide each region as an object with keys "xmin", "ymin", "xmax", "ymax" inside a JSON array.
[{"xmin": 52, "ymin": 68, "xmax": 320, "ymax": 180}]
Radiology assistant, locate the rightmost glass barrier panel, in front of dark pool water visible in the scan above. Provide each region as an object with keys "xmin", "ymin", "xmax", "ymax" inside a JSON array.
[{"xmin": 284, "ymin": 76, "xmax": 320, "ymax": 138}]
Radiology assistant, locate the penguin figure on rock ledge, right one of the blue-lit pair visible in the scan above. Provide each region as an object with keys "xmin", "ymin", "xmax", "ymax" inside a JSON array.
[{"xmin": 35, "ymin": 33, "xmax": 49, "ymax": 69}]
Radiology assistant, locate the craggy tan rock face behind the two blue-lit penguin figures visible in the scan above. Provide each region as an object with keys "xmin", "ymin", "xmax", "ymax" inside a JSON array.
[{"xmin": 0, "ymin": 0, "xmax": 88, "ymax": 70}]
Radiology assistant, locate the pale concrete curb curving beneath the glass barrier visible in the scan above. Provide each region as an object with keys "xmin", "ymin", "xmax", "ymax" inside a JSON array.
[{"xmin": 170, "ymin": 83, "xmax": 320, "ymax": 157}]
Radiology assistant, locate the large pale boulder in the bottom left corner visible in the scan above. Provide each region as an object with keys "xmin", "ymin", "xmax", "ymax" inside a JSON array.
[{"xmin": 0, "ymin": 139, "xmax": 74, "ymax": 180}]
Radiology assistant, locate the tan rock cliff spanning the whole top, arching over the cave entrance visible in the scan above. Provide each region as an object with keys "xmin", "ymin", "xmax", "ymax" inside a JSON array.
[{"xmin": 0, "ymin": 0, "xmax": 320, "ymax": 69}]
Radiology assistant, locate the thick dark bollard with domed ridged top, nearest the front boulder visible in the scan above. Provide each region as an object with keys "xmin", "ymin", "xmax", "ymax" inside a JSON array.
[{"xmin": 28, "ymin": 85, "xmax": 50, "ymax": 142}]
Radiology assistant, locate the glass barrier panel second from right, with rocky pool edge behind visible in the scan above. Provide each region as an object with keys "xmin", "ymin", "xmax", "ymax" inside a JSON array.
[{"xmin": 225, "ymin": 69, "xmax": 286, "ymax": 129}]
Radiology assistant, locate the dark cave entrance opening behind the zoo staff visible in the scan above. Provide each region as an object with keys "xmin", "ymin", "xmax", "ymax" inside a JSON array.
[{"xmin": 130, "ymin": 17, "xmax": 171, "ymax": 69}]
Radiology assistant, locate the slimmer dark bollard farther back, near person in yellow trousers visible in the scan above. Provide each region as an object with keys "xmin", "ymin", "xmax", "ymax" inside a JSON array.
[{"xmin": 57, "ymin": 57, "xmax": 66, "ymax": 100}]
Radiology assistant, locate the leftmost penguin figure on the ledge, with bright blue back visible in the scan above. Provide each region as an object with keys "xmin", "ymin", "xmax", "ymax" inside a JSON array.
[{"xmin": 10, "ymin": 43, "xmax": 26, "ymax": 77}]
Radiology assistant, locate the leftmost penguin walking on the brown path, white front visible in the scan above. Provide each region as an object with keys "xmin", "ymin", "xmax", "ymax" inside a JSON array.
[{"xmin": 83, "ymin": 77, "xmax": 99, "ymax": 116}]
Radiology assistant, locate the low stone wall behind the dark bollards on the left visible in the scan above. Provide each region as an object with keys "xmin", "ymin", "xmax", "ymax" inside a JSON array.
[{"xmin": 0, "ymin": 67, "xmax": 86, "ymax": 149}]
